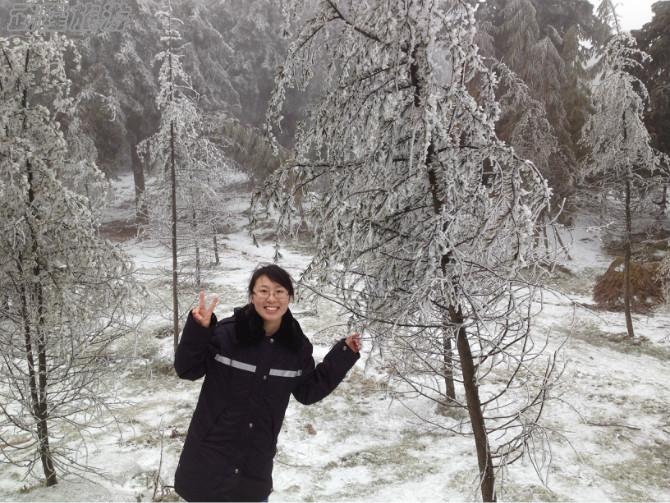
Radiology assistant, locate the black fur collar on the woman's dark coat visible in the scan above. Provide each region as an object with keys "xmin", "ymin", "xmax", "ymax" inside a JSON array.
[{"xmin": 233, "ymin": 304, "xmax": 305, "ymax": 351}]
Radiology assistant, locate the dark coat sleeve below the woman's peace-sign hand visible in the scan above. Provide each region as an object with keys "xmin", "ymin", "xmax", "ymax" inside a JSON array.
[{"xmin": 174, "ymin": 311, "xmax": 216, "ymax": 381}]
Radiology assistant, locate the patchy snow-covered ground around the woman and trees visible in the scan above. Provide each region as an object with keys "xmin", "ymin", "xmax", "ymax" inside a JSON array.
[{"xmin": 0, "ymin": 175, "xmax": 670, "ymax": 501}]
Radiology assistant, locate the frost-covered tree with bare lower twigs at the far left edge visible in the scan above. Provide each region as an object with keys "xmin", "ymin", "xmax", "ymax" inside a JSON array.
[{"xmin": 0, "ymin": 33, "xmax": 133, "ymax": 485}]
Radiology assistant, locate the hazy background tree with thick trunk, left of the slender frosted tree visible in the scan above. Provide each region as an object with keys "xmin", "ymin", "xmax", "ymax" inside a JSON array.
[{"xmin": 72, "ymin": 0, "xmax": 167, "ymax": 224}]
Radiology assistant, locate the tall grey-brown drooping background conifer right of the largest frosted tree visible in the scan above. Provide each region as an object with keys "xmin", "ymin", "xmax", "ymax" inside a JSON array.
[{"xmin": 477, "ymin": 0, "xmax": 597, "ymax": 209}]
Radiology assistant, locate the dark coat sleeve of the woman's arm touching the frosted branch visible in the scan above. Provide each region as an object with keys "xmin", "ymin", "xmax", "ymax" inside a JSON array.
[{"xmin": 293, "ymin": 339, "xmax": 361, "ymax": 405}]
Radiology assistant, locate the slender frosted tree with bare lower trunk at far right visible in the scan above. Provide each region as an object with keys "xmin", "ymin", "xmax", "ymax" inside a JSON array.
[{"xmin": 582, "ymin": 0, "xmax": 660, "ymax": 338}]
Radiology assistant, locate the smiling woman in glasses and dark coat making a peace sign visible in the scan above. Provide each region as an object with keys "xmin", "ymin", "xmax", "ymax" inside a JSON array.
[{"xmin": 174, "ymin": 265, "xmax": 361, "ymax": 501}]
